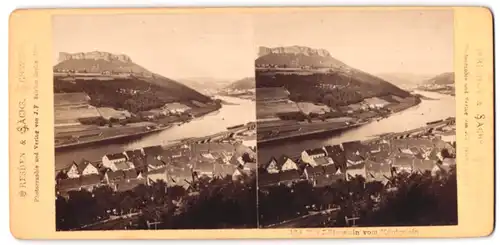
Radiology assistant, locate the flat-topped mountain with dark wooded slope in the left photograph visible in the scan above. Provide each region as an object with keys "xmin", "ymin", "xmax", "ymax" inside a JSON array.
[{"xmin": 54, "ymin": 51, "xmax": 212, "ymax": 112}]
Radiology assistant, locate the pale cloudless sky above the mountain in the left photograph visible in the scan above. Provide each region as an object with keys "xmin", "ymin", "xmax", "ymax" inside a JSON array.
[{"xmin": 53, "ymin": 13, "xmax": 255, "ymax": 80}]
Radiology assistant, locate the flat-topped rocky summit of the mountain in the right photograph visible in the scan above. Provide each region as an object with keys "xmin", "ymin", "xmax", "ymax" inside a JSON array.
[{"xmin": 255, "ymin": 46, "xmax": 345, "ymax": 68}]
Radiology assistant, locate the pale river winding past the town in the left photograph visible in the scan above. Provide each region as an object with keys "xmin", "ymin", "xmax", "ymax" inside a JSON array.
[{"xmin": 55, "ymin": 96, "xmax": 255, "ymax": 170}]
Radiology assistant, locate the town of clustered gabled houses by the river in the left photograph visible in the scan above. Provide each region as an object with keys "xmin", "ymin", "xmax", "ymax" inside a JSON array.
[{"xmin": 56, "ymin": 124, "xmax": 256, "ymax": 195}]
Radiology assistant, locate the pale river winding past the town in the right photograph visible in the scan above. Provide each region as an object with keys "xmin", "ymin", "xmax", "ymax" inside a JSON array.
[{"xmin": 257, "ymin": 91, "xmax": 456, "ymax": 163}]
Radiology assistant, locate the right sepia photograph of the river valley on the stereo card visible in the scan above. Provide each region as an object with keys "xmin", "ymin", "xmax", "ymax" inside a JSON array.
[{"xmin": 254, "ymin": 10, "xmax": 458, "ymax": 228}]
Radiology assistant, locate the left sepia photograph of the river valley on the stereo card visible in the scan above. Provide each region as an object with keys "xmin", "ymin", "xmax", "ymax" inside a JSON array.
[{"xmin": 52, "ymin": 12, "xmax": 258, "ymax": 231}]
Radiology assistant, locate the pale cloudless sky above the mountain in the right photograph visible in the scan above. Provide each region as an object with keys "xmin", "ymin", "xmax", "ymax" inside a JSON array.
[{"xmin": 254, "ymin": 10, "xmax": 453, "ymax": 74}]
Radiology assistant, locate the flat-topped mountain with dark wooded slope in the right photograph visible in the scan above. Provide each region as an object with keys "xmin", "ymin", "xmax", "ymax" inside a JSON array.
[{"xmin": 255, "ymin": 46, "xmax": 410, "ymax": 106}]
